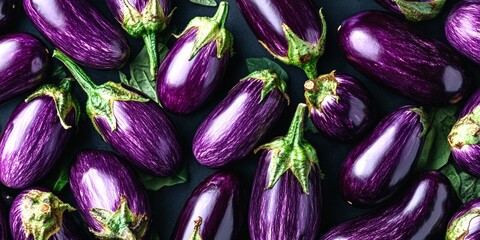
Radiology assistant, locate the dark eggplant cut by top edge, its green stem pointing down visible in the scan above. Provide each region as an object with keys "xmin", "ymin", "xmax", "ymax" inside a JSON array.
[{"xmin": 237, "ymin": 0, "xmax": 327, "ymax": 79}]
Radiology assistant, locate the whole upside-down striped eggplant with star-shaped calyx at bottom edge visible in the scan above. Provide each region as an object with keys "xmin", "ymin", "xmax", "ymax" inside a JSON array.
[{"xmin": 70, "ymin": 150, "xmax": 150, "ymax": 239}]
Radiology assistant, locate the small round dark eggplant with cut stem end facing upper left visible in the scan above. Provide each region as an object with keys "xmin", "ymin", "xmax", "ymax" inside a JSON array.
[{"xmin": 304, "ymin": 71, "xmax": 375, "ymax": 141}]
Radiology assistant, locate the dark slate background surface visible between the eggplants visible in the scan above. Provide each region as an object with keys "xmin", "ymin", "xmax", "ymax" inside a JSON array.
[{"xmin": 0, "ymin": 0, "xmax": 478, "ymax": 239}]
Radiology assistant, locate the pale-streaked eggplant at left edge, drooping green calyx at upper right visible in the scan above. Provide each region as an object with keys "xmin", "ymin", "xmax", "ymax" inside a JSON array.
[{"xmin": 0, "ymin": 79, "xmax": 80, "ymax": 189}]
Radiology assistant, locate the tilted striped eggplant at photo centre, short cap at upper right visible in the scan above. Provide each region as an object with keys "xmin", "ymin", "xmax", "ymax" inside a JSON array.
[{"xmin": 193, "ymin": 70, "xmax": 289, "ymax": 168}]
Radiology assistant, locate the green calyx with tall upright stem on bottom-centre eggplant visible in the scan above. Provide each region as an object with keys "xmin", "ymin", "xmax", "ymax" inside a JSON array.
[{"xmin": 255, "ymin": 103, "xmax": 318, "ymax": 194}]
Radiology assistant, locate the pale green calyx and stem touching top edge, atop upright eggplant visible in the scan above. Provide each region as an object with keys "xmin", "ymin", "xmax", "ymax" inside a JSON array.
[{"xmin": 176, "ymin": 2, "xmax": 233, "ymax": 60}]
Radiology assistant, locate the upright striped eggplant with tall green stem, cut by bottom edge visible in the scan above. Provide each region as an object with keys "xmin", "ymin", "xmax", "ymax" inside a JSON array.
[{"xmin": 248, "ymin": 103, "xmax": 322, "ymax": 240}]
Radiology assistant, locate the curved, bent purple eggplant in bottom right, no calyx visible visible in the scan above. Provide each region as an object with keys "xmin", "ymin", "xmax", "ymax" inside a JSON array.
[{"xmin": 320, "ymin": 171, "xmax": 454, "ymax": 240}]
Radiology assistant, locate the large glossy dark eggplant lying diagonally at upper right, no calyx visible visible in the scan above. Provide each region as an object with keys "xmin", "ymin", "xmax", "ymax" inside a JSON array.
[{"xmin": 338, "ymin": 11, "xmax": 471, "ymax": 105}]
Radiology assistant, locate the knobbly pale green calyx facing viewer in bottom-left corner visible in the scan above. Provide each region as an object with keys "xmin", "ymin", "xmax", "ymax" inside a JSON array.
[{"xmin": 20, "ymin": 190, "xmax": 75, "ymax": 240}]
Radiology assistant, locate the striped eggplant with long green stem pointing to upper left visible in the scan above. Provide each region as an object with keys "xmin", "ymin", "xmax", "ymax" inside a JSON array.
[{"xmin": 54, "ymin": 50, "xmax": 181, "ymax": 176}]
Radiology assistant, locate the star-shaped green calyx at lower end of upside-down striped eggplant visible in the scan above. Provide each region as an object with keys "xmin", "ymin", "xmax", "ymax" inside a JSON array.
[{"xmin": 90, "ymin": 195, "xmax": 148, "ymax": 240}]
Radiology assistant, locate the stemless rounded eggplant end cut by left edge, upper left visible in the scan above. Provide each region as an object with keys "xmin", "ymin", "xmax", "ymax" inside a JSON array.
[{"xmin": 0, "ymin": 33, "xmax": 50, "ymax": 103}]
